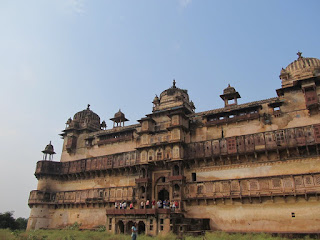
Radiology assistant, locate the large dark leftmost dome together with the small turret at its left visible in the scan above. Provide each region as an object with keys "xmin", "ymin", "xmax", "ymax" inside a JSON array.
[{"xmin": 66, "ymin": 104, "xmax": 100, "ymax": 131}]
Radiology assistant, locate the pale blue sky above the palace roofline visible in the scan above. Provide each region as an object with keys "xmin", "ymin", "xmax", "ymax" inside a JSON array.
[{"xmin": 0, "ymin": 0, "xmax": 320, "ymax": 217}]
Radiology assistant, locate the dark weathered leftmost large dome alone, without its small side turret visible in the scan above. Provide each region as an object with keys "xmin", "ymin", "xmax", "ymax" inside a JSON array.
[{"xmin": 73, "ymin": 104, "xmax": 100, "ymax": 129}]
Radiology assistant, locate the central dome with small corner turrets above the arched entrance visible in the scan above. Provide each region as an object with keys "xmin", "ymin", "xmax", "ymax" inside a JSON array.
[{"xmin": 152, "ymin": 80, "xmax": 195, "ymax": 113}]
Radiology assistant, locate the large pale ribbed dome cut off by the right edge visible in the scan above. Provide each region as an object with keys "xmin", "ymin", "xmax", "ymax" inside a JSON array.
[{"xmin": 279, "ymin": 52, "xmax": 320, "ymax": 88}]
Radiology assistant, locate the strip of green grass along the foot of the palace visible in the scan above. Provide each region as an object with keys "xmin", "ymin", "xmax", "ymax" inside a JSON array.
[{"xmin": 0, "ymin": 229, "xmax": 311, "ymax": 240}]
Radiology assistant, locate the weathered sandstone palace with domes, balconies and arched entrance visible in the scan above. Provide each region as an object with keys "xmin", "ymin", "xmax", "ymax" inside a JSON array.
[{"xmin": 28, "ymin": 53, "xmax": 320, "ymax": 235}]
